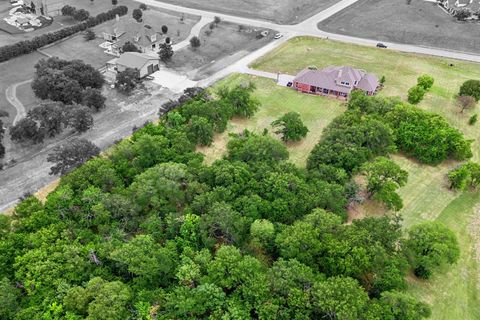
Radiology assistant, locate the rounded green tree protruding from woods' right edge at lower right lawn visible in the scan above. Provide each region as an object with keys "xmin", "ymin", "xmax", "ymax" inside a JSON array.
[{"xmin": 406, "ymin": 222, "xmax": 460, "ymax": 279}]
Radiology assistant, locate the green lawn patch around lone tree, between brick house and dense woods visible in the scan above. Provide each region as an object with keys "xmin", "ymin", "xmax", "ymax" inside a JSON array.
[{"xmin": 198, "ymin": 74, "xmax": 346, "ymax": 166}]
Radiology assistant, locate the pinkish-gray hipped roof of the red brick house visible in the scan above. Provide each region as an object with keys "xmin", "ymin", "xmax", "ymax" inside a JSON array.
[{"xmin": 294, "ymin": 66, "xmax": 379, "ymax": 94}]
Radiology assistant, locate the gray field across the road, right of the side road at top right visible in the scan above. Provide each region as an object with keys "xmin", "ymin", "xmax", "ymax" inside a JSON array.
[{"xmin": 319, "ymin": 0, "xmax": 480, "ymax": 53}]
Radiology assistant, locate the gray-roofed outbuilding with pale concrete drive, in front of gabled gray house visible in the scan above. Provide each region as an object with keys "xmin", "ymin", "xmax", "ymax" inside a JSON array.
[{"xmin": 104, "ymin": 52, "xmax": 160, "ymax": 83}]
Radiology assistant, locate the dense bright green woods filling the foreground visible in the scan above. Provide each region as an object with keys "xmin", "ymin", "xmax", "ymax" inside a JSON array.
[{"xmin": 0, "ymin": 84, "xmax": 465, "ymax": 320}]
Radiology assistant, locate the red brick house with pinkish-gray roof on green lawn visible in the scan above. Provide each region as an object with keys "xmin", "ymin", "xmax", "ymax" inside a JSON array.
[{"xmin": 292, "ymin": 66, "xmax": 379, "ymax": 99}]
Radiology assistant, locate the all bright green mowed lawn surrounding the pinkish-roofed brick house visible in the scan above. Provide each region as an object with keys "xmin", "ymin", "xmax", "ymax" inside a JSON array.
[{"xmin": 208, "ymin": 38, "xmax": 480, "ymax": 320}]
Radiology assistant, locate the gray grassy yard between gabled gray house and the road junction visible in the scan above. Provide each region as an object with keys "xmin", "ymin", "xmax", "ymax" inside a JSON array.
[{"xmin": 168, "ymin": 21, "xmax": 274, "ymax": 80}]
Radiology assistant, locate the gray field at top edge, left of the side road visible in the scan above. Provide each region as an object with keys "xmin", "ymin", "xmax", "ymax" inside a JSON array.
[{"xmin": 156, "ymin": 0, "xmax": 340, "ymax": 24}]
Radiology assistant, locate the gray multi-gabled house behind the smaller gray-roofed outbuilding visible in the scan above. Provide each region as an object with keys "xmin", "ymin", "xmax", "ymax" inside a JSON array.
[{"xmin": 102, "ymin": 16, "xmax": 163, "ymax": 56}]
